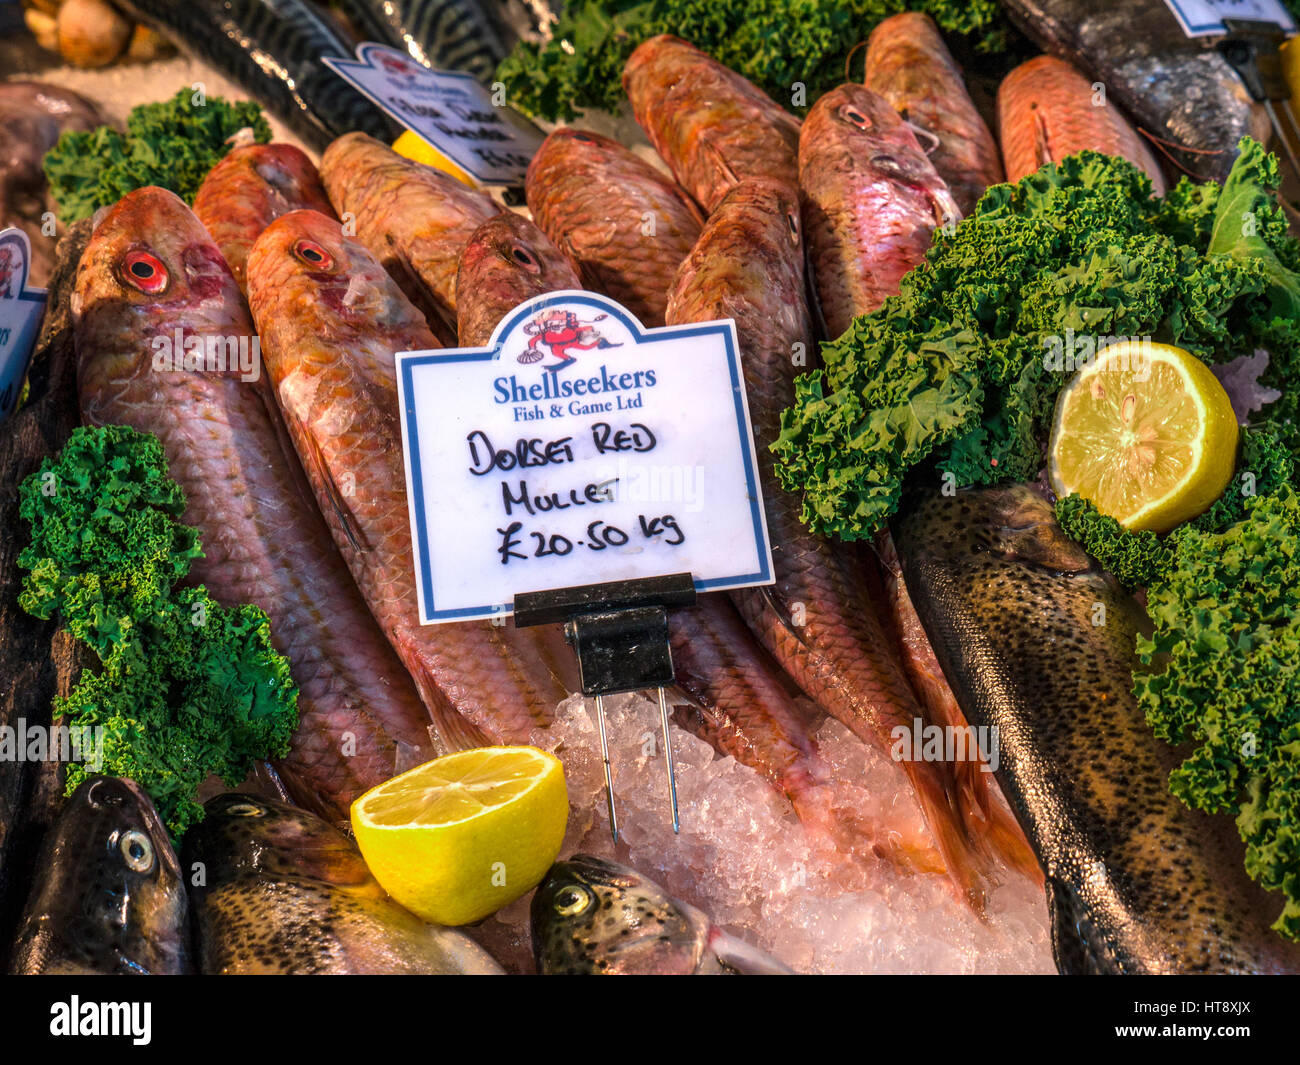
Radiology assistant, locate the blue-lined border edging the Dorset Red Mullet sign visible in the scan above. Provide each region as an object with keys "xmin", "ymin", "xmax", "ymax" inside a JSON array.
[{"xmin": 397, "ymin": 290, "xmax": 774, "ymax": 624}]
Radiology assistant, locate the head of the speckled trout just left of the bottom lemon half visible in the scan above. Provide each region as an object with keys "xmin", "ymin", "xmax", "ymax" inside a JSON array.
[{"xmin": 185, "ymin": 792, "xmax": 373, "ymax": 888}]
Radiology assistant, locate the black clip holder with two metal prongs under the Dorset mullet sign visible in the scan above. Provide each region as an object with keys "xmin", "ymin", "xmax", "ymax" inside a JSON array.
[{"xmin": 515, "ymin": 573, "xmax": 696, "ymax": 843}]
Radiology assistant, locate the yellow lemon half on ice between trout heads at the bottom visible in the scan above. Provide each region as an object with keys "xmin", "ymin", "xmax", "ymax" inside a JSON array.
[{"xmin": 352, "ymin": 746, "xmax": 568, "ymax": 925}]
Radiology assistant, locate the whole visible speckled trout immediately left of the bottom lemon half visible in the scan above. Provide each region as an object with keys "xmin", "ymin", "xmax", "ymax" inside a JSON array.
[{"xmin": 183, "ymin": 793, "xmax": 502, "ymax": 975}]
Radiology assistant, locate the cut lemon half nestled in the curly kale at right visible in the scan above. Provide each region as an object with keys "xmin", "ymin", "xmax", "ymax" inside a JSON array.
[{"xmin": 1048, "ymin": 341, "xmax": 1238, "ymax": 533}]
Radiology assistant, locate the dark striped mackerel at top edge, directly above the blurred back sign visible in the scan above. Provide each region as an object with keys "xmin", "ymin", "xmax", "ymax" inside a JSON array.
[{"xmin": 339, "ymin": 0, "xmax": 506, "ymax": 82}]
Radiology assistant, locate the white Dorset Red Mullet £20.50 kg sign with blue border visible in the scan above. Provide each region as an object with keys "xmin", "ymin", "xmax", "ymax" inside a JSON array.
[{"xmin": 397, "ymin": 291, "xmax": 772, "ymax": 624}]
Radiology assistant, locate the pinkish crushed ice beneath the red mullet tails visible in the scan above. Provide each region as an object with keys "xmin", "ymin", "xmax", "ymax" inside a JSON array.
[{"xmin": 476, "ymin": 696, "xmax": 1056, "ymax": 973}]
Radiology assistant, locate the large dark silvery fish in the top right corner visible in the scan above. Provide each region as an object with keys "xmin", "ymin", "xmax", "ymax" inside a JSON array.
[{"xmin": 1002, "ymin": 0, "xmax": 1269, "ymax": 181}]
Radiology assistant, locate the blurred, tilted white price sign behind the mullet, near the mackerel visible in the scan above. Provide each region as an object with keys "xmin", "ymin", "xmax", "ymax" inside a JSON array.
[{"xmin": 330, "ymin": 42, "xmax": 542, "ymax": 185}]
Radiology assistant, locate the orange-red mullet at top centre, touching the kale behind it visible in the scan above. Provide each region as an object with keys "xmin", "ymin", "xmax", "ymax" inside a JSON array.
[{"xmin": 623, "ymin": 35, "xmax": 800, "ymax": 212}]
